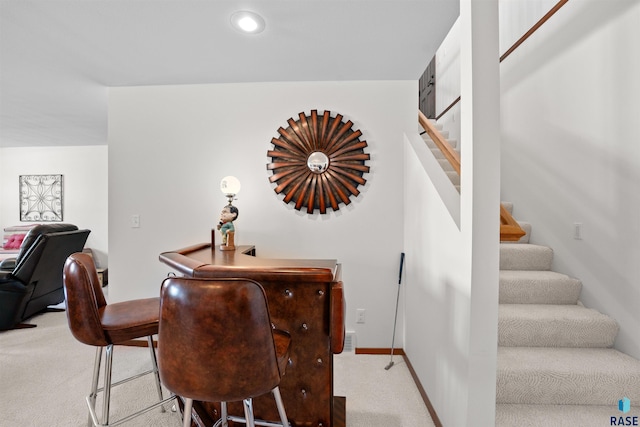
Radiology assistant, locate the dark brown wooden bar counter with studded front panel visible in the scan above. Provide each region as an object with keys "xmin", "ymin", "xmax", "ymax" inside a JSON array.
[{"xmin": 160, "ymin": 244, "xmax": 346, "ymax": 427}]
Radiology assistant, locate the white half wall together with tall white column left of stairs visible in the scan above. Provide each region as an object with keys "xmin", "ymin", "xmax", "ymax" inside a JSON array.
[{"xmin": 405, "ymin": 0, "xmax": 500, "ymax": 426}]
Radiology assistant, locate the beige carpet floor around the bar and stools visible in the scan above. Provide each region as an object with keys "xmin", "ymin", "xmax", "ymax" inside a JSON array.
[{"xmin": 0, "ymin": 312, "xmax": 433, "ymax": 427}]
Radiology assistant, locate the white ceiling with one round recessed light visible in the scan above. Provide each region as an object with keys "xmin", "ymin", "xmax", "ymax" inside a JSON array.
[{"xmin": 0, "ymin": 0, "xmax": 459, "ymax": 147}]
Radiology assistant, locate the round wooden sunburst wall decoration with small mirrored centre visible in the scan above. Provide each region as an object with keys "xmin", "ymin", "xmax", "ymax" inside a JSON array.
[{"xmin": 267, "ymin": 110, "xmax": 370, "ymax": 214}]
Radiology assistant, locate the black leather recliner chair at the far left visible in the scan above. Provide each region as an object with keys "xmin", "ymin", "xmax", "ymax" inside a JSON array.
[{"xmin": 0, "ymin": 224, "xmax": 91, "ymax": 330}]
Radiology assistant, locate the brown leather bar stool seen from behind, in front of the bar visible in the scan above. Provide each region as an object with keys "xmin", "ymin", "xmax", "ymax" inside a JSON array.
[{"xmin": 158, "ymin": 277, "xmax": 291, "ymax": 427}]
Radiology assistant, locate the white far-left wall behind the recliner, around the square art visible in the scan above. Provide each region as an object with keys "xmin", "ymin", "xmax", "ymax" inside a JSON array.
[{"xmin": 0, "ymin": 145, "xmax": 109, "ymax": 267}]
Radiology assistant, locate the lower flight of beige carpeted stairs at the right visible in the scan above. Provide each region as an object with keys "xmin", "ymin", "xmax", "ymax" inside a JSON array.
[{"xmin": 496, "ymin": 203, "xmax": 640, "ymax": 427}]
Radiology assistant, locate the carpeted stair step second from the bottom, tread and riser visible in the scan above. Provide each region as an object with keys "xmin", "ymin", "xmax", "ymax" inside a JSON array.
[{"xmin": 496, "ymin": 347, "xmax": 640, "ymax": 404}]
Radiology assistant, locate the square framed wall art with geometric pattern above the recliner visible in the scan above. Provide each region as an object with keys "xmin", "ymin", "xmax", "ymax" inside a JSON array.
[{"xmin": 20, "ymin": 175, "xmax": 63, "ymax": 222}]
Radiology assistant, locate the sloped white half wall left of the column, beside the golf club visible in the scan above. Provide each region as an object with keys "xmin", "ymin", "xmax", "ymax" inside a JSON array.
[{"xmin": 404, "ymin": 140, "xmax": 471, "ymax": 426}]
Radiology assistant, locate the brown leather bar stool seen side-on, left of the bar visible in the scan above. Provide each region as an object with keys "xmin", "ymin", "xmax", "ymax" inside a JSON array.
[{"xmin": 63, "ymin": 253, "xmax": 174, "ymax": 426}]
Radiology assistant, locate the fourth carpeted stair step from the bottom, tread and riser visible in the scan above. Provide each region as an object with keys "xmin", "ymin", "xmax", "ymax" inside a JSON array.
[{"xmin": 500, "ymin": 270, "xmax": 582, "ymax": 304}]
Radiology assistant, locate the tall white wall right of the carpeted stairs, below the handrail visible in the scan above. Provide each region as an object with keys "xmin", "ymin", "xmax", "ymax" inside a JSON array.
[{"xmin": 501, "ymin": 0, "xmax": 640, "ymax": 358}]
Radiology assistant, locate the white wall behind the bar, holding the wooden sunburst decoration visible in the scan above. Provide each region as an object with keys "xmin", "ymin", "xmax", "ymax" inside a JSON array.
[{"xmin": 109, "ymin": 81, "xmax": 417, "ymax": 347}]
